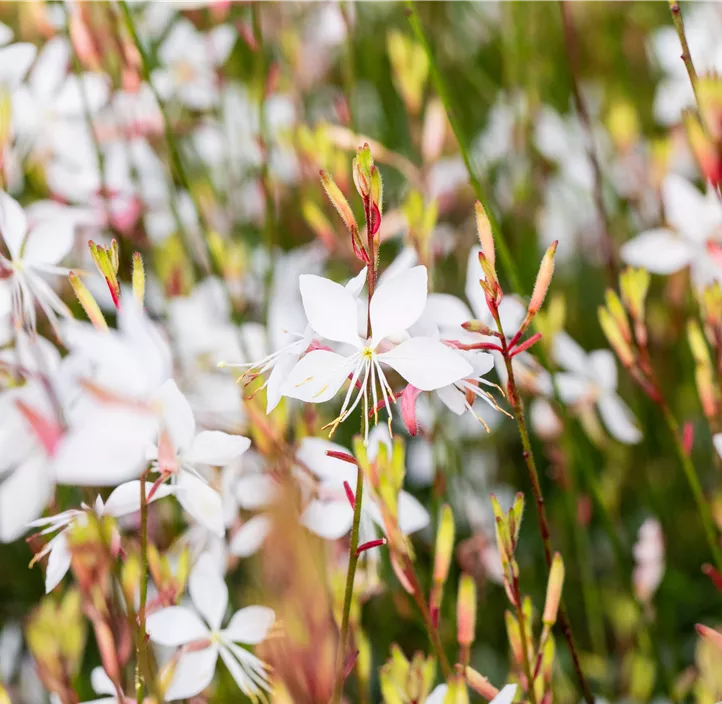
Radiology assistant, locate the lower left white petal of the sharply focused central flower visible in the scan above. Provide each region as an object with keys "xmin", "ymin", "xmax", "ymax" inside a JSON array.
[{"xmin": 283, "ymin": 350, "xmax": 357, "ymax": 403}]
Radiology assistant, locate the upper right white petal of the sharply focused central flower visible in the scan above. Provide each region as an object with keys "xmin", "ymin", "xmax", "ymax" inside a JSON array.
[{"xmin": 370, "ymin": 266, "xmax": 428, "ymax": 347}]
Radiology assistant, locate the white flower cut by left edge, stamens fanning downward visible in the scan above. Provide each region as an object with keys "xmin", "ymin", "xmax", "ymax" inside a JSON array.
[{"xmin": 0, "ymin": 191, "xmax": 75, "ymax": 333}]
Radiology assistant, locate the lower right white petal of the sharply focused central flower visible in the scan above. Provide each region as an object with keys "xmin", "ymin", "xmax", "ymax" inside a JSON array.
[{"xmin": 378, "ymin": 337, "xmax": 473, "ymax": 391}]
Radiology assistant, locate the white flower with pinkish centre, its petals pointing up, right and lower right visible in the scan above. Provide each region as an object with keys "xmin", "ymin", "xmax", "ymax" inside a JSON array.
[{"xmin": 148, "ymin": 379, "xmax": 251, "ymax": 536}]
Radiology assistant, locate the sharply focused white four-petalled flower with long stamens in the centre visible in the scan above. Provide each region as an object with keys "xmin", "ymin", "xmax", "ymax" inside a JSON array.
[{"xmin": 283, "ymin": 266, "xmax": 472, "ymax": 439}]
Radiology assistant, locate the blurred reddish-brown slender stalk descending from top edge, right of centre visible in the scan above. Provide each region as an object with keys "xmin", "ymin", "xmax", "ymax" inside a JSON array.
[{"xmin": 559, "ymin": 0, "xmax": 618, "ymax": 286}]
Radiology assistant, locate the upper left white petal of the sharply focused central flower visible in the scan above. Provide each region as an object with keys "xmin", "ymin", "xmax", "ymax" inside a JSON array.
[{"xmin": 299, "ymin": 274, "xmax": 360, "ymax": 347}]
